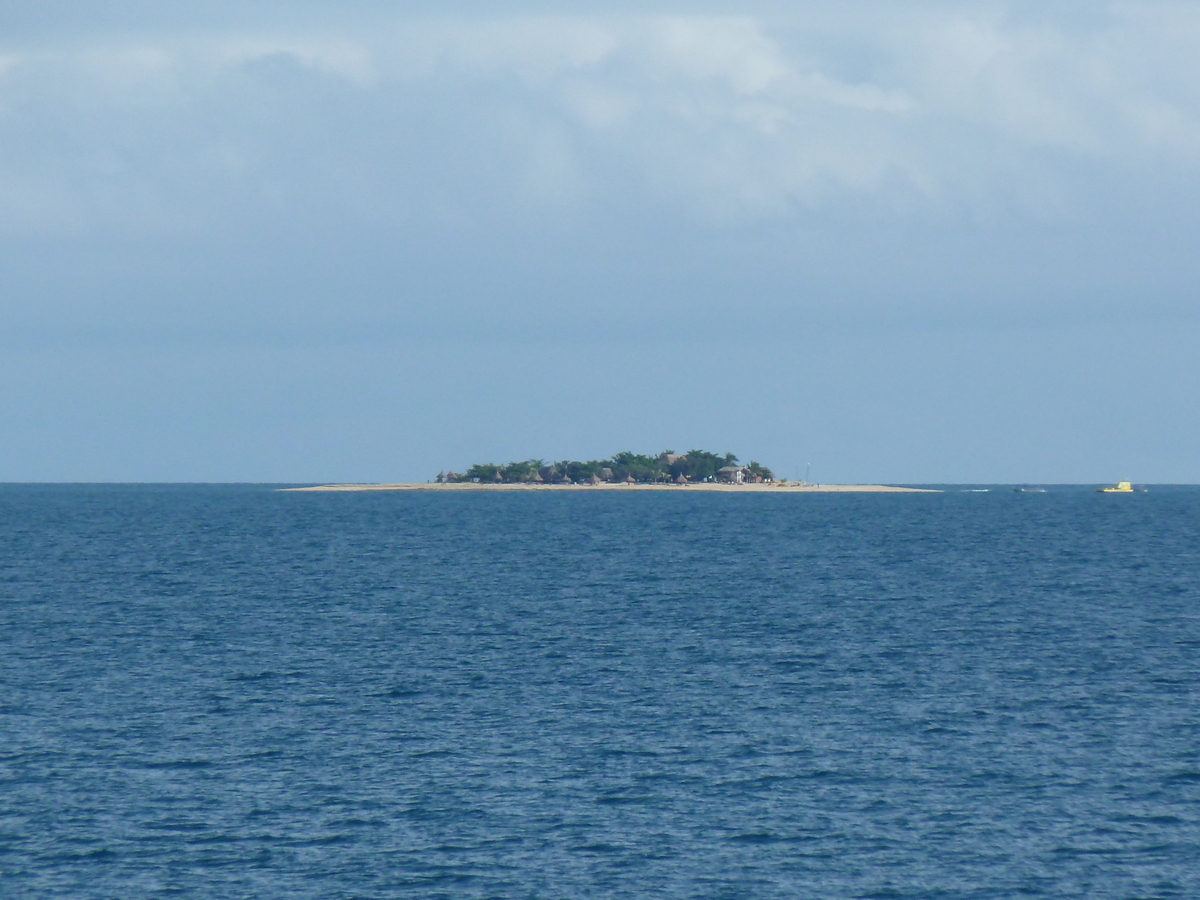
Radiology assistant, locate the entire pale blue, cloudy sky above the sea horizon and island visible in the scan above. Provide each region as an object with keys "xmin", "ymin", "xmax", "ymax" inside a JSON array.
[{"xmin": 0, "ymin": 0, "xmax": 1200, "ymax": 484}]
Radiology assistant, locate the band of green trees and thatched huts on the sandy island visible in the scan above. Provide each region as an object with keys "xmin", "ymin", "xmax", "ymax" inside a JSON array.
[{"xmin": 437, "ymin": 450, "xmax": 775, "ymax": 485}]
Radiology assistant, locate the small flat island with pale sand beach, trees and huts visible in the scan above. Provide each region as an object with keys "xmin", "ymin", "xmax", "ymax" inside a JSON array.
[{"xmin": 283, "ymin": 450, "xmax": 937, "ymax": 493}]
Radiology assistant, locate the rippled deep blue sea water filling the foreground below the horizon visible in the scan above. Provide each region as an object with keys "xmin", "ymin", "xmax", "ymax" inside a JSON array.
[{"xmin": 0, "ymin": 486, "xmax": 1200, "ymax": 899}]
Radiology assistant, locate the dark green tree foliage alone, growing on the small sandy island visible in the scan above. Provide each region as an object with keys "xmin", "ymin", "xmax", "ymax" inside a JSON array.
[{"xmin": 452, "ymin": 450, "xmax": 774, "ymax": 484}]
